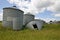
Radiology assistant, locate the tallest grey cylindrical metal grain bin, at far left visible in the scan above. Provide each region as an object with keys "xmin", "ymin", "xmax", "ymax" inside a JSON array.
[{"xmin": 3, "ymin": 6, "xmax": 24, "ymax": 30}]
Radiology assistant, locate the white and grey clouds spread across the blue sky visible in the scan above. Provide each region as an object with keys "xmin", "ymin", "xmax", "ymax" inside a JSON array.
[{"xmin": 8, "ymin": 0, "xmax": 60, "ymax": 22}]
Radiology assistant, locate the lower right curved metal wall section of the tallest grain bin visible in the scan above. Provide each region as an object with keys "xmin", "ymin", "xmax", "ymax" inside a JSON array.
[{"xmin": 13, "ymin": 17, "xmax": 23, "ymax": 30}]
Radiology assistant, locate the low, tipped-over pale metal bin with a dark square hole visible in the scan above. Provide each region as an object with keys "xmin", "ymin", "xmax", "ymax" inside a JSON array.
[{"xmin": 26, "ymin": 19, "xmax": 43, "ymax": 30}]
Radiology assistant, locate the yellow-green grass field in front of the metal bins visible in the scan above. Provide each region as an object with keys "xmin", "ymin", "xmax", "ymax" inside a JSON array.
[{"xmin": 0, "ymin": 22, "xmax": 60, "ymax": 40}]
